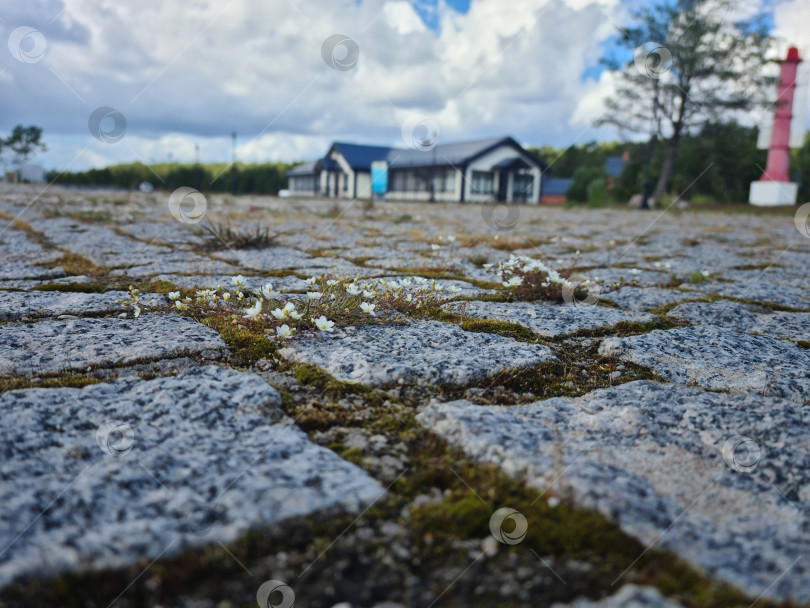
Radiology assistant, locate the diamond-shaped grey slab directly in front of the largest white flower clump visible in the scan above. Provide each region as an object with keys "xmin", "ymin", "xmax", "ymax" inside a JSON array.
[{"xmin": 279, "ymin": 321, "xmax": 555, "ymax": 388}]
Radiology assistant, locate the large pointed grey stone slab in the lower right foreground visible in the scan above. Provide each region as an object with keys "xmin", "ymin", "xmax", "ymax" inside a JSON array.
[{"xmin": 417, "ymin": 381, "xmax": 810, "ymax": 605}]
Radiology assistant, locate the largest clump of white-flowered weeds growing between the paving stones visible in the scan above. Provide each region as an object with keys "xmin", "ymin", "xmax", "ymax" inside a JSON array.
[{"xmin": 119, "ymin": 276, "xmax": 446, "ymax": 343}]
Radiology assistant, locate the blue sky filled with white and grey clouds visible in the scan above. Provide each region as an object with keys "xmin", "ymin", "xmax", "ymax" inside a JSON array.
[{"xmin": 0, "ymin": 0, "xmax": 810, "ymax": 170}]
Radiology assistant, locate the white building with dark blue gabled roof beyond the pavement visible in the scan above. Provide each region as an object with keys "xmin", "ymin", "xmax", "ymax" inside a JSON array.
[{"xmin": 287, "ymin": 137, "xmax": 548, "ymax": 204}]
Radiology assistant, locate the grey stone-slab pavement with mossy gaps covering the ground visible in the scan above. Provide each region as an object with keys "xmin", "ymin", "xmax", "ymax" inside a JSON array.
[{"xmin": 0, "ymin": 186, "xmax": 810, "ymax": 608}]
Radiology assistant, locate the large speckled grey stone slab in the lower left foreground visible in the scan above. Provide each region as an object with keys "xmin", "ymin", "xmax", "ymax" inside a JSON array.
[{"xmin": 0, "ymin": 367, "xmax": 383, "ymax": 586}]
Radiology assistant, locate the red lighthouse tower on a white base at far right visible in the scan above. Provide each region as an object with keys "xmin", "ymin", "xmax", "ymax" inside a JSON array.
[{"xmin": 748, "ymin": 46, "xmax": 802, "ymax": 206}]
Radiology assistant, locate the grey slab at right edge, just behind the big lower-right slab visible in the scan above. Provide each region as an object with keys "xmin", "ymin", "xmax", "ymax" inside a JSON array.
[{"xmin": 599, "ymin": 326, "xmax": 810, "ymax": 403}]
